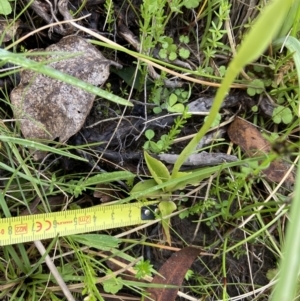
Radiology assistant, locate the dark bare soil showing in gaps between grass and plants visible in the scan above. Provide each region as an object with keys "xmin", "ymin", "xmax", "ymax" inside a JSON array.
[{"xmin": 2, "ymin": 0, "xmax": 276, "ymax": 301}]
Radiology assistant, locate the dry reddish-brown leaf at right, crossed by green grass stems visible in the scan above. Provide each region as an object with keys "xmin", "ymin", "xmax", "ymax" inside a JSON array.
[{"xmin": 227, "ymin": 117, "xmax": 295, "ymax": 187}]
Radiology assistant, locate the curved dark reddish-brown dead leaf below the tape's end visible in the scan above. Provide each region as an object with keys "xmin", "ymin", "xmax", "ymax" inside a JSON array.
[{"xmin": 145, "ymin": 247, "xmax": 200, "ymax": 301}]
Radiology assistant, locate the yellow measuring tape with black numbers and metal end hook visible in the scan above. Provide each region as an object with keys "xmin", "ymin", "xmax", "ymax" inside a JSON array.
[{"xmin": 0, "ymin": 201, "xmax": 158, "ymax": 246}]
